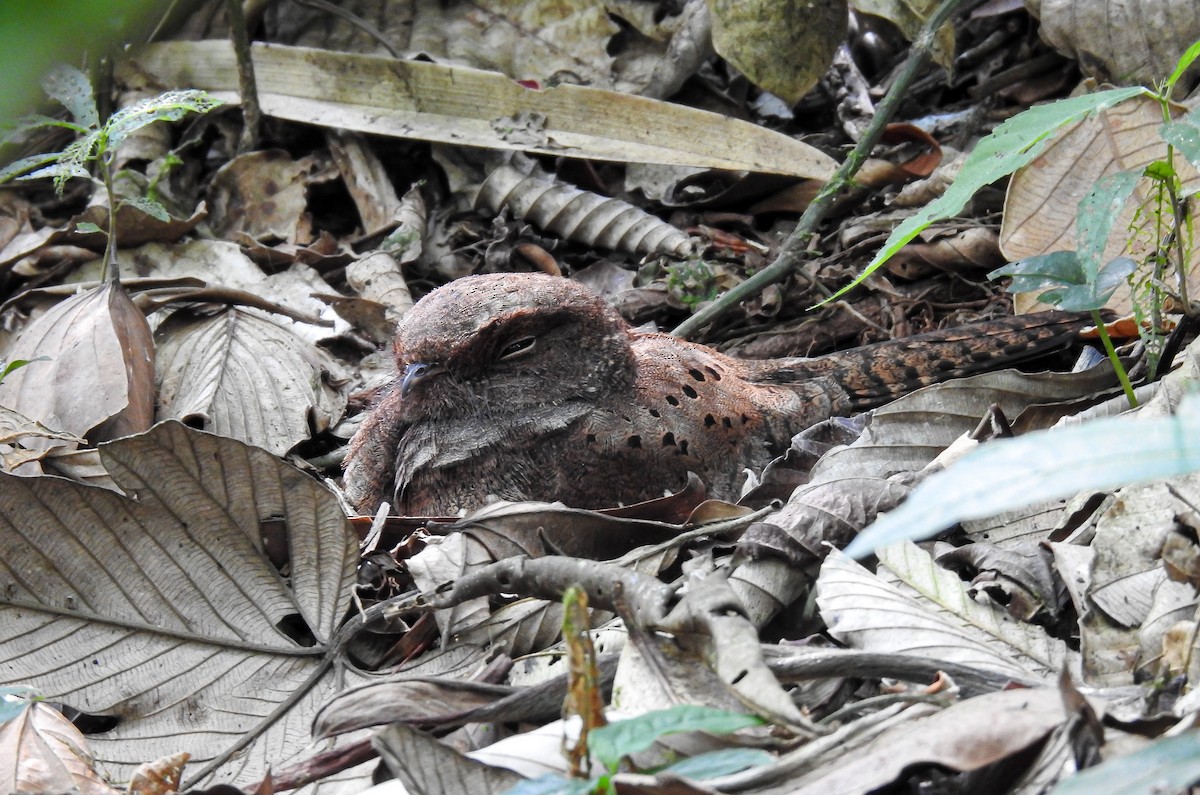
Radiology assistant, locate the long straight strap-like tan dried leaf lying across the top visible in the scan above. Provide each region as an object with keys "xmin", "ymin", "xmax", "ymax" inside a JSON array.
[{"xmin": 122, "ymin": 41, "xmax": 835, "ymax": 179}]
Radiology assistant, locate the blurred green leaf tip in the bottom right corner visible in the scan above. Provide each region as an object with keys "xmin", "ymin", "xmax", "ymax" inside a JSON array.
[{"xmin": 1050, "ymin": 729, "xmax": 1200, "ymax": 795}]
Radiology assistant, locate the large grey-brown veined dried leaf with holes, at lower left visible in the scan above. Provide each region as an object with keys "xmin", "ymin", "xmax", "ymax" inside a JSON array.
[{"xmin": 0, "ymin": 423, "xmax": 358, "ymax": 782}]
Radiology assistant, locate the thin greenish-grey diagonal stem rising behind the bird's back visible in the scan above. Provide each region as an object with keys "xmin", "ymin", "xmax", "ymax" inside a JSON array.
[{"xmin": 672, "ymin": 0, "xmax": 961, "ymax": 337}]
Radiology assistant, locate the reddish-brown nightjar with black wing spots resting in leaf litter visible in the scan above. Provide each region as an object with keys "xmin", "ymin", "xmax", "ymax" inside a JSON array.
[{"xmin": 343, "ymin": 274, "xmax": 1086, "ymax": 516}]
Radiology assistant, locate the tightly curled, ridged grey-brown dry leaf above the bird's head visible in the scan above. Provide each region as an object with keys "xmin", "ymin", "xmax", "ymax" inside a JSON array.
[{"xmin": 475, "ymin": 166, "xmax": 694, "ymax": 257}]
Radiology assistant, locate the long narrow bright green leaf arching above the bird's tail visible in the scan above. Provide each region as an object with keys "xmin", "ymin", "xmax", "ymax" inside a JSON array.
[{"xmin": 822, "ymin": 86, "xmax": 1150, "ymax": 303}]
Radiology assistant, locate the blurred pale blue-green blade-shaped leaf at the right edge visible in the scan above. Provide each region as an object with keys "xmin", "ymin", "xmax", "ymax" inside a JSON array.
[{"xmin": 846, "ymin": 395, "xmax": 1200, "ymax": 557}]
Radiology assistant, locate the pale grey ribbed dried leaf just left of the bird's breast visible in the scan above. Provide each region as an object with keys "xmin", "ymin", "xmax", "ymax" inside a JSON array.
[{"xmin": 156, "ymin": 307, "xmax": 346, "ymax": 455}]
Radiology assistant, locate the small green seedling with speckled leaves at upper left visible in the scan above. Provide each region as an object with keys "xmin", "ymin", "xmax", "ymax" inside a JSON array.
[{"xmin": 0, "ymin": 66, "xmax": 222, "ymax": 283}]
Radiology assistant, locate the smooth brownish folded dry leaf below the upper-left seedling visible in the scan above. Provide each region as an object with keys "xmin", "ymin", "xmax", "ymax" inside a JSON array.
[{"xmin": 0, "ymin": 282, "xmax": 155, "ymax": 442}]
